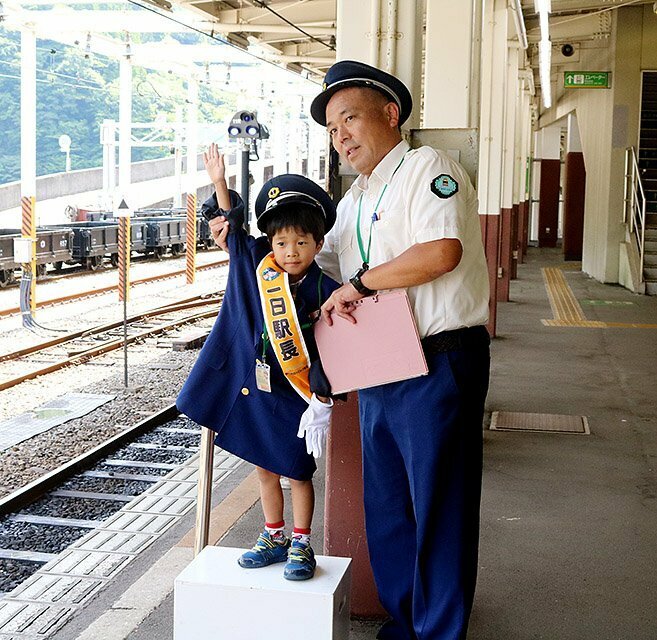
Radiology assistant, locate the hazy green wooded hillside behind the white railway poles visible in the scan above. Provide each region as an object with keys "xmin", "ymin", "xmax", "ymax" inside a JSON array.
[{"xmin": 0, "ymin": 28, "xmax": 241, "ymax": 184}]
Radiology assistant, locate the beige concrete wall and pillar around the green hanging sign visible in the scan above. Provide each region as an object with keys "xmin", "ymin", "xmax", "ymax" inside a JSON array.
[{"xmin": 540, "ymin": 5, "xmax": 657, "ymax": 282}]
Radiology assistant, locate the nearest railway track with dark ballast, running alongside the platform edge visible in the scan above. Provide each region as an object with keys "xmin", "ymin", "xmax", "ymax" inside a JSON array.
[{"xmin": 0, "ymin": 405, "xmax": 187, "ymax": 593}]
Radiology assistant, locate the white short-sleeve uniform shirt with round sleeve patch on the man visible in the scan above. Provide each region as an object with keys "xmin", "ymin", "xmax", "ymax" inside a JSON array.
[{"xmin": 317, "ymin": 141, "xmax": 489, "ymax": 337}]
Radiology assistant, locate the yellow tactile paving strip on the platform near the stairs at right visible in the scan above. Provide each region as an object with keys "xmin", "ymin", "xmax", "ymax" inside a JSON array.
[{"xmin": 541, "ymin": 267, "xmax": 657, "ymax": 329}]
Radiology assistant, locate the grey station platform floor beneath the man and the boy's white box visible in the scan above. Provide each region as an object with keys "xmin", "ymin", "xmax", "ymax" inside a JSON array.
[{"xmin": 55, "ymin": 248, "xmax": 657, "ymax": 640}]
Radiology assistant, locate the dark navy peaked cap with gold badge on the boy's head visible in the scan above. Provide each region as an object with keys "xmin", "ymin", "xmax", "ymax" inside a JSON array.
[{"xmin": 255, "ymin": 173, "xmax": 335, "ymax": 233}]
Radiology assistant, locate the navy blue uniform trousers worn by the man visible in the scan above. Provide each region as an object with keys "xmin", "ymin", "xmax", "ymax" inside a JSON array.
[{"xmin": 358, "ymin": 327, "xmax": 490, "ymax": 640}]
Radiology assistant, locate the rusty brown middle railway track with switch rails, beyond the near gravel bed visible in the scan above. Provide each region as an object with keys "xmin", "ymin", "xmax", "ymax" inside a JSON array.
[{"xmin": 0, "ymin": 292, "xmax": 223, "ymax": 391}]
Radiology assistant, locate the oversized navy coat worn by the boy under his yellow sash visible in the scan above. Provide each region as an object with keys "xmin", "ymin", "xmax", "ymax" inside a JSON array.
[{"xmin": 176, "ymin": 192, "xmax": 339, "ymax": 480}]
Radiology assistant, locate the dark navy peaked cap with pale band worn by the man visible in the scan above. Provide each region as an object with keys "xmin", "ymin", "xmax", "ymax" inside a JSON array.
[{"xmin": 310, "ymin": 60, "xmax": 413, "ymax": 127}]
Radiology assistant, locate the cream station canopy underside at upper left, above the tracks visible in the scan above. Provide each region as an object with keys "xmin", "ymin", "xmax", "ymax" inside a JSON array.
[{"xmin": 0, "ymin": 0, "xmax": 335, "ymax": 83}]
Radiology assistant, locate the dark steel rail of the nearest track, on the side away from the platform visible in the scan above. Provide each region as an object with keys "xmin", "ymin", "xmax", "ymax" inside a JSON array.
[{"xmin": 0, "ymin": 404, "xmax": 180, "ymax": 516}]
